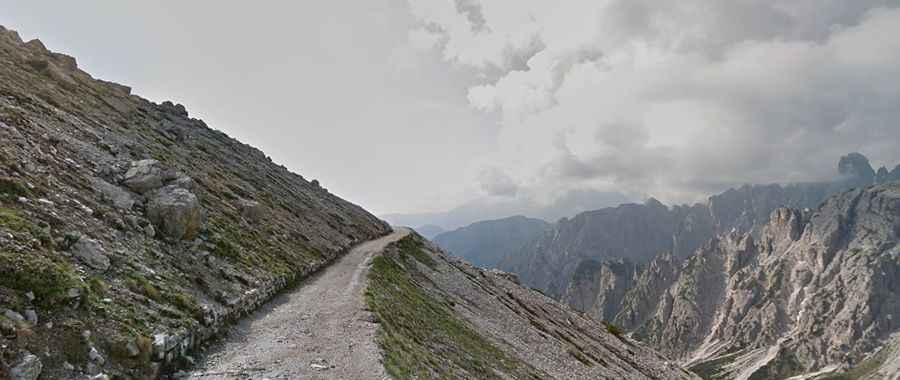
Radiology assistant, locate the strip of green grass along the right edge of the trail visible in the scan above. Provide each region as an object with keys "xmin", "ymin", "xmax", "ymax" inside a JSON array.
[{"xmin": 366, "ymin": 236, "xmax": 540, "ymax": 379}]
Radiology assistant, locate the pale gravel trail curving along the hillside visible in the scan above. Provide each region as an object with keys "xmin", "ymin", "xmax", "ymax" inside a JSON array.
[{"xmin": 188, "ymin": 228, "xmax": 409, "ymax": 380}]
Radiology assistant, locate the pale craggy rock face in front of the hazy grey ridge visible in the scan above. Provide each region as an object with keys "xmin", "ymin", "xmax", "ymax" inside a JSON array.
[{"xmin": 615, "ymin": 182, "xmax": 900, "ymax": 379}]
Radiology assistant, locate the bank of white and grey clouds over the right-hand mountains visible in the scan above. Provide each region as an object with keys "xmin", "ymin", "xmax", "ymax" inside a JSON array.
[{"xmin": 409, "ymin": 0, "xmax": 900, "ymax": 202}]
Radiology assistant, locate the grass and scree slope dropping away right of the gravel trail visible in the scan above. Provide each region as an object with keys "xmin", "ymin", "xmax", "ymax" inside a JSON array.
[{"xmin": 367, "ymin": 235, "xmax": 697, "ymax": 380}]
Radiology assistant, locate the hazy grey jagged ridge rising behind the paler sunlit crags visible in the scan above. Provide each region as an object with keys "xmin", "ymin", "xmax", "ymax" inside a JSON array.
[{"xmin": 500, "ymin": 153, "xmax": 888, "ymax": 300}]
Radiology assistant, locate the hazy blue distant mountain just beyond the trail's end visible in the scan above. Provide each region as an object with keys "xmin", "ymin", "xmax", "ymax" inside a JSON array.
[{"xmin": 431, "ymin": 216, "xmax": 550, "ymax": 268}]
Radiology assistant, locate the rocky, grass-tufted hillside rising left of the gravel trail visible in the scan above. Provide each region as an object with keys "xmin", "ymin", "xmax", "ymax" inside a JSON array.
[{"xmin": 0, "ymin": 28, "xmax": 389, "ymax": 379}]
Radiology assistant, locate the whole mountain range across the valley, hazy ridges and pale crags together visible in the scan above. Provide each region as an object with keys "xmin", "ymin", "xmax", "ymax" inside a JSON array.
[{"xmin": 430, "ymin": 153, "xmax": 900, "ymax": 379}]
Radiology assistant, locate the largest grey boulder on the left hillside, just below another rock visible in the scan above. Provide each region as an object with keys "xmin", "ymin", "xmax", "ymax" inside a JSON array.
[{"xmin": 147, "ymin": 185, "xmax": 203, "ymax": 240}]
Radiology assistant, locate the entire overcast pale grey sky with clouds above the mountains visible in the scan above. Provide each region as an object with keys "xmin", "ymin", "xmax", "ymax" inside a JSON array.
[{"xmin": 0, "ymin": 0, "xmax": 900, "ymax": 214}]
